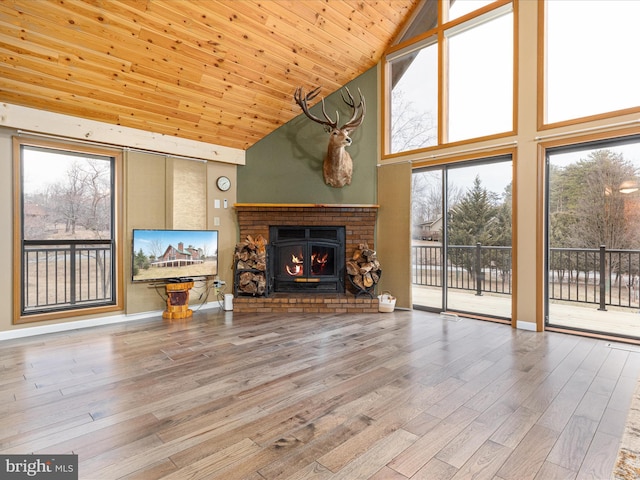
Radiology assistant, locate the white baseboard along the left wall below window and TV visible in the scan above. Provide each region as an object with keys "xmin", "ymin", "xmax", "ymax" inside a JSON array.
[{"xmin": 0, "ymin": 300, "xmax": 222, "ymax": 342}]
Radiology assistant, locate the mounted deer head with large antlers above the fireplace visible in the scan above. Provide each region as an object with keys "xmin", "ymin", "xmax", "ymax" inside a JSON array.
[{"xmin": 293, "ymin": 87, "xmax": 366, "ymax": 188}]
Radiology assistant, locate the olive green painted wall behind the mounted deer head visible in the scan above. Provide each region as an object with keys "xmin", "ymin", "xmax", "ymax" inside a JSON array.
[{"xmin": 238, "ymin": 67, "xmax": 378, "ymax": 204}]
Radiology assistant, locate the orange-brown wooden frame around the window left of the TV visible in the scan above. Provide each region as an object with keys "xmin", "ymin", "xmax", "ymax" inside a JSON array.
[{"xmin": 13, "ymin": 136, "xmax": 124, "ymax": 325}]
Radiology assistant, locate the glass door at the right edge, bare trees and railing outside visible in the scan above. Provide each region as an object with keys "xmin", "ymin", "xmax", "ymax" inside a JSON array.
[{"xmin": 546, "ymin": 136, "xmax": 640, "ymax": 338}]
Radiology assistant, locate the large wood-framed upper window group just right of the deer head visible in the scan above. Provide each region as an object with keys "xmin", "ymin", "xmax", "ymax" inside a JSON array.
[{"xmin": 385, "ymin": 0, "xmax": 514, "ymax": 154}]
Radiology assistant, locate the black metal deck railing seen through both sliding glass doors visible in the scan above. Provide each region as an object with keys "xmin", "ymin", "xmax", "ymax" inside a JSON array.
[{"xmin": 412, "ymin": 244, "xmax": 640, "ymax": 310}]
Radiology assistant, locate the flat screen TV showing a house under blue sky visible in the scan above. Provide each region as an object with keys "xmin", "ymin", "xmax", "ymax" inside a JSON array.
[{"xmin": 131, "ymin": 229, "xmax": 218, "ymax": 282}]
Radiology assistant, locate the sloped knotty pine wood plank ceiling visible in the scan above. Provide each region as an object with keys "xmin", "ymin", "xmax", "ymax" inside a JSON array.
[{"xmin": 0, "ymin": 0, "xmax": 424, "ymax": 149}]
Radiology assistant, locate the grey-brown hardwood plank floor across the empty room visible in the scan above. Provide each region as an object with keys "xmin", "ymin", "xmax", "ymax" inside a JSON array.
[{"xmin": 0, "ymin": 311, "xmax": 640, "ymax": 480}]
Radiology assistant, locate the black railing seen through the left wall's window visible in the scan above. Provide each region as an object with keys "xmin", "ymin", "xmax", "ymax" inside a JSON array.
[{"xmin": 22, "ymin": 240, "xmax": 114, "ymax": 314}]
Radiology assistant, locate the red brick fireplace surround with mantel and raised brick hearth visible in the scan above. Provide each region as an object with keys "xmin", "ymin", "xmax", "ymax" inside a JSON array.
[{"xmin": 234, "ymin": 203, "xmax": 378, "ymax": 313}]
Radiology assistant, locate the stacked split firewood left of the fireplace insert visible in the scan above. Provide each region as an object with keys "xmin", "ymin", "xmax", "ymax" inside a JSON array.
[{"xmin": 233, "ymin": 235, "xmax": 267, "ymax": 295}]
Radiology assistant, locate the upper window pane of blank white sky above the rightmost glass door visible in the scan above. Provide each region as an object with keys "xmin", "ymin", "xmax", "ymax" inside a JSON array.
[{"xmin": 542, "ymin": 0, "xmax": 640, "ymax": 124}]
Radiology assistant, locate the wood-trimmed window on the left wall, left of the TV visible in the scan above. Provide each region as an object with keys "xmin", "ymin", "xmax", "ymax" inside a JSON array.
[{"xmin": 14, "ymin": 137, "xmax": 120, "ymax": 323}]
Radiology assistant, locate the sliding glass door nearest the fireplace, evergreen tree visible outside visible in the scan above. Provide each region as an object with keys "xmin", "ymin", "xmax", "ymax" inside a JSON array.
[{"xmin": 412, "ymin": 156, "xmax": 513, "ymax": 320}]
